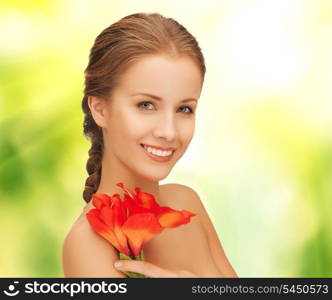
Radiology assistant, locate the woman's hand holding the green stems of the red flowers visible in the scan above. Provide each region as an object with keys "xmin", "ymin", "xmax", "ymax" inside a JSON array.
[{"xmin": 114, "ymin": 260, "xmax": 199, "ymax": 278}]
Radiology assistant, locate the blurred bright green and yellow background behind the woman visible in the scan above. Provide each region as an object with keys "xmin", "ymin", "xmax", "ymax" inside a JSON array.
[{"xmin": 0, "ymin": 0, "xmax": 332, "ymax": 277}]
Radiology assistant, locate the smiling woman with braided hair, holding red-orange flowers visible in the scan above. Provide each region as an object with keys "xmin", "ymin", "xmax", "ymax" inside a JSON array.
[{"xmin": 63, "ymin": 13, "xmax": 237, "ymax": 277}]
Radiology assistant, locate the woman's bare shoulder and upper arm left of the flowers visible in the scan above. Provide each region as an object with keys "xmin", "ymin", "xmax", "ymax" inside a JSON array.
[{"xmin": 62, "ymin": 214, "xmax": 126, "ymax": 277}]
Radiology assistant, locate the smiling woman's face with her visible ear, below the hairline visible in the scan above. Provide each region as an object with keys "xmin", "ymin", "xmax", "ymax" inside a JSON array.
[{"xmin": 103, "ymin": 55, "xmax": 202, "ymax": 181}]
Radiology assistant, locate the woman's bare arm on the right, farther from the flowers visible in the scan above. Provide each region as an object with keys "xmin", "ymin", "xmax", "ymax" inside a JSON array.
[{"xmin": 185, "ymin": 186, "xmax": 238, "ymax": 277}]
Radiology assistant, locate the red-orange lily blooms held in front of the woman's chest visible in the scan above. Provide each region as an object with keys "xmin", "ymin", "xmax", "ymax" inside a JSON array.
[{"xmin": 86, "ymin": 183, "xmax": 195, "ymax": 257}]
